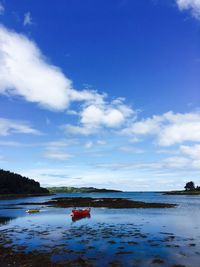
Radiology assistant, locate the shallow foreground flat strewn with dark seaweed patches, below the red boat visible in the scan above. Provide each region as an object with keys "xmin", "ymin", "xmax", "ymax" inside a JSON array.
[{"xmin": 0, "ymin": 222, "xmax": 199, "ymax": 267}]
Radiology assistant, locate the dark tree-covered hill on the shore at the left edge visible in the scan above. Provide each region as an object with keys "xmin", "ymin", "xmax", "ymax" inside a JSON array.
[{"xmin": 0, "ymin": 169, "xmax": 49, "ymax": 195}]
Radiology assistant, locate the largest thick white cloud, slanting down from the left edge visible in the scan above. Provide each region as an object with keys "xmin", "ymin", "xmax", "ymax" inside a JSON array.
[{"xmin": 0, "ymin": 26, "xmax": 104, "ymax": 110}]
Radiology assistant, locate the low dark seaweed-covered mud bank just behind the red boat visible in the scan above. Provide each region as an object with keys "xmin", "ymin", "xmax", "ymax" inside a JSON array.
[{"xmin": 19, "ymin": 197, "xmax": 176, "ymax": 209}]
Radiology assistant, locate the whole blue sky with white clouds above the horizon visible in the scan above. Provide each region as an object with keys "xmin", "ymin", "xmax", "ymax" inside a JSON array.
[{"xmin": 0, "ymin": 0, "xmax": 200, "ymax": 191}]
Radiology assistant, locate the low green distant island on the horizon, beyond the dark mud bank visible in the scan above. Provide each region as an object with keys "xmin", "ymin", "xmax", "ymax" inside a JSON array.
[{"xmin": 48, "ymin": 186, "xmax": 122, "ymax": 193}]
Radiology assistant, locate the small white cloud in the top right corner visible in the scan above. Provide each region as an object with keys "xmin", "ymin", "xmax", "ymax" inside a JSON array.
[{"xmin": 176, "ymin": 0, "xmax": 200, "ymax": 19}]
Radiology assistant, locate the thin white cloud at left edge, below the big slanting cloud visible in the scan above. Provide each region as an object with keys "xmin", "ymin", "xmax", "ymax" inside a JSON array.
[{"xmin": 0, "ymin": 118, "xmax": 40, "ymax": 136}]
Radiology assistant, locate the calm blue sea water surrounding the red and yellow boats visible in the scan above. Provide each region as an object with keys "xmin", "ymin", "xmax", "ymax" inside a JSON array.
[{"xmin": 0, "ymin": 192, "xmax": 200, "ymax": 267}]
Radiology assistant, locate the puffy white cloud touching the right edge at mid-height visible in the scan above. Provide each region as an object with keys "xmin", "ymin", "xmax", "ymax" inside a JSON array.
[{"xmin": 122, "ymin": 111, "xmax": 200, "ymax": 146}]
